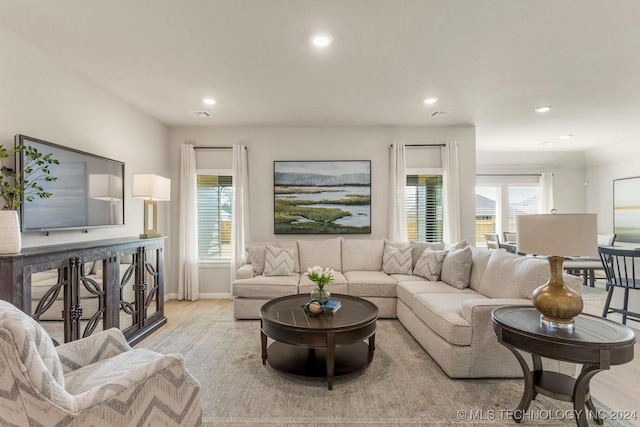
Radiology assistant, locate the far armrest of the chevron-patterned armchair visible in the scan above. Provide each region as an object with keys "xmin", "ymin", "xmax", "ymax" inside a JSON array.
[{"xmin": 56, "ymin": 328, "xmax": 131, "ymax": 374}]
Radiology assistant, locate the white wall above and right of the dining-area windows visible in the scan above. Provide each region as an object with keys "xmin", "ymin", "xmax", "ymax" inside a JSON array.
[{"xmin": 476, "ymin": 151, "xmax": 595, "ymax": 213}]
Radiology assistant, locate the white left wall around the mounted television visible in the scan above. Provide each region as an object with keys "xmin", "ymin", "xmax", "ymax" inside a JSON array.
[{"xmin": 0, "ymin": 27, "xmax": 169, "ymax": 247}]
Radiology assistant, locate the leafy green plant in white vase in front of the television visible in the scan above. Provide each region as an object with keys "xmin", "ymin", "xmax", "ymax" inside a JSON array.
[{"xmin": 0, "ymin": 145, "xmax": 59, "ymax": 254}]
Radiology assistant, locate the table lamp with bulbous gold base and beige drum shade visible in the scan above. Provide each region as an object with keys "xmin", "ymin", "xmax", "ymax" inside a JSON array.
[{"xmin": 516, "ymin": 214, "xmax": 598, "ymax": 329}]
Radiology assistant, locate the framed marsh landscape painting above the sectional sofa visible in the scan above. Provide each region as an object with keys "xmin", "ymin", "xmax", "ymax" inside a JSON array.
[{"xmin": 273, "ymin": 160, "xmax": 371, "ymax": 234}]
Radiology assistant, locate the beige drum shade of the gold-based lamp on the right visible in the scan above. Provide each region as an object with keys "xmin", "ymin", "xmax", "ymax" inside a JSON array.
[{"xmin": 516, "ymin": 214, "xmax": 598, "ymax": 257}]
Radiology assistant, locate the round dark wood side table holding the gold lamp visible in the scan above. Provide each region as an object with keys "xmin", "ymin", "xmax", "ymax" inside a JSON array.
[{"xmin": 491, "ymin": 306, "xmax": 636, "ymax": 427}]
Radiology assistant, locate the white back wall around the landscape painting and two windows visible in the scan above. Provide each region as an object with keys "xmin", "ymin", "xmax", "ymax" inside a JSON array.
[{"xmin": 167, "ymin": 127, "xmax": 476, "ymax": 297}]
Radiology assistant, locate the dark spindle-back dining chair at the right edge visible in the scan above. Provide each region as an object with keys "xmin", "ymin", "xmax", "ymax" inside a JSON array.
[{"xmin": 598, "ymin": 247, "xmax": 640, "ymax": 325}]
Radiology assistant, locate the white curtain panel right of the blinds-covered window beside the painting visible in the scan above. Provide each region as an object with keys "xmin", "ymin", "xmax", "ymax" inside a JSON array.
[{"xmin": 442, "ymin": 141, "xmax": 462, "ymax": 243}]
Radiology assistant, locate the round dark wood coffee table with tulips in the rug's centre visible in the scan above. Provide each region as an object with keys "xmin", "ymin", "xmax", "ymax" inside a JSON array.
[{"xmin": 260, "ymin": 294, "xmax": 378, "ymax": 390}]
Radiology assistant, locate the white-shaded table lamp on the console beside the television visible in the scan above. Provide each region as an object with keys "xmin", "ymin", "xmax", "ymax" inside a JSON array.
[{"xmin": 132, "ymin": 173, "xmax": 171, "ymax": 239}]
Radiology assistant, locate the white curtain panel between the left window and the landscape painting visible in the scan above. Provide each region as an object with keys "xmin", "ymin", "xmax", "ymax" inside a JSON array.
[{"xmin": 229, "ymin": 144, "xmax": 251, "ymax": 292}]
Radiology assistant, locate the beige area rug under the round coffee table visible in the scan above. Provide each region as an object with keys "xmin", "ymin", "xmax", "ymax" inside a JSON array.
[{"xmin": 153, "ymin": 314, "xmax": 631, "ymax": 426}]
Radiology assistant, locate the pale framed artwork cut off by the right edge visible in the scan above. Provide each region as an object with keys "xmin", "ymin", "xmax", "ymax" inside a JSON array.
[{"xmin": 613, "ymin": 177, "xmax": 640, "ymax": 243}]
